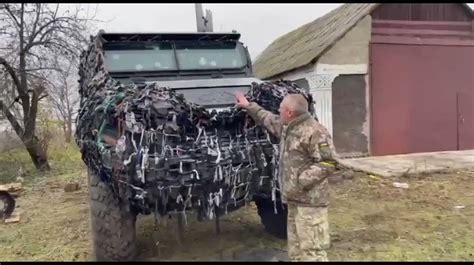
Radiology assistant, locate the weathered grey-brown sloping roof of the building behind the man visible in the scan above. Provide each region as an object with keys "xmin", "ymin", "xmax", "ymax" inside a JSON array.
[{"xmin": 253, "ymin": 4, "xmax": 472, "ymax": 79}]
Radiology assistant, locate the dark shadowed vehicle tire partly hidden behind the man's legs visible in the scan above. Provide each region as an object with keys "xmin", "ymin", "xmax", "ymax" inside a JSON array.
[{"xmin": 255, "ymin": 197, "xmax": 288, "ymax": 239}]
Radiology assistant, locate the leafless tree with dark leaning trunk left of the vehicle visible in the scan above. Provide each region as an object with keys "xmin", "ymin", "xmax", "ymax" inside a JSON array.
[{"xmin": 0, "ymin": 3, "xmax": 95, "ymax": 171}]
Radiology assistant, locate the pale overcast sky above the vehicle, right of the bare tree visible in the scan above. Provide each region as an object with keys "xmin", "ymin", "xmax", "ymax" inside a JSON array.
[{"xmin": 97, "ymin": 4, "xmax": 474, "ymax": 58}]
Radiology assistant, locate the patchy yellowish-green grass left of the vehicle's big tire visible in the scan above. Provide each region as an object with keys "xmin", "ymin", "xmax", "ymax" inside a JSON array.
[{"xmin": 0, "ymin": 138, "xmax": 90, "ymax": 261}]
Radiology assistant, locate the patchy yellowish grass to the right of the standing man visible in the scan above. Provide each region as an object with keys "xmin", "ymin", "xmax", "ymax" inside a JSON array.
[{"xmin": 330, "ymin": 172, "xmax": 474, "ymax": 261}]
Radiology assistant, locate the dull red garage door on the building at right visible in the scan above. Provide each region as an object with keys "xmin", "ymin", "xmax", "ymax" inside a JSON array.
[{"xmin": 370, "ymin": 43, "xmax": 474, "ymax": 155}]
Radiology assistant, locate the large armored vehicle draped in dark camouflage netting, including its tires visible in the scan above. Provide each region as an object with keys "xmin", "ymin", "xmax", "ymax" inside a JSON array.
[{"xmin": 76, "ymin": 31, "xmax": 312, "ymax": 260}]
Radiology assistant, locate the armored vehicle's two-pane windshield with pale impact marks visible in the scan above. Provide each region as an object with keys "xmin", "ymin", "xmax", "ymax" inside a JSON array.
[{"xmin": 104, "ymin": 41, "xmax": 247, "ymax": 72}]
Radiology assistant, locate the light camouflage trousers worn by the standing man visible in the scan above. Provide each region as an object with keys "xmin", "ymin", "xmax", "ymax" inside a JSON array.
[{"xmin": 288, "ymin": 203, "xmax": 330, "ymax": 261}]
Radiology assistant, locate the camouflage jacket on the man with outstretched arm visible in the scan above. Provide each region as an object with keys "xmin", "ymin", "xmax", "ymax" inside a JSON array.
[{"xmin": 247, "ymin": 103, "xmax": 336, "ymax": 207}]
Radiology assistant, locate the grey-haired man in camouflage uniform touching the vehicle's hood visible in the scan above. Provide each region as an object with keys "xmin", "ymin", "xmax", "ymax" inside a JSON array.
[{"xmin": 235, "ymin": 92, "xmax": 336, "ymax": 261}]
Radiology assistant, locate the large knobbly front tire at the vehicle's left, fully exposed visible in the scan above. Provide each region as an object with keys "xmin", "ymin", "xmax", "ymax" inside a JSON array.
[{"xmin": 89, "ymin": 171, "xmax": 137, "ymax": 261}]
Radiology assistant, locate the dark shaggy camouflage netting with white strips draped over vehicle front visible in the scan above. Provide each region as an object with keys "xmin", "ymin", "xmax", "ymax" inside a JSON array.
[{"xmin": 76, "ymin": 35, "xmax": 312, "ymax": 219}]
